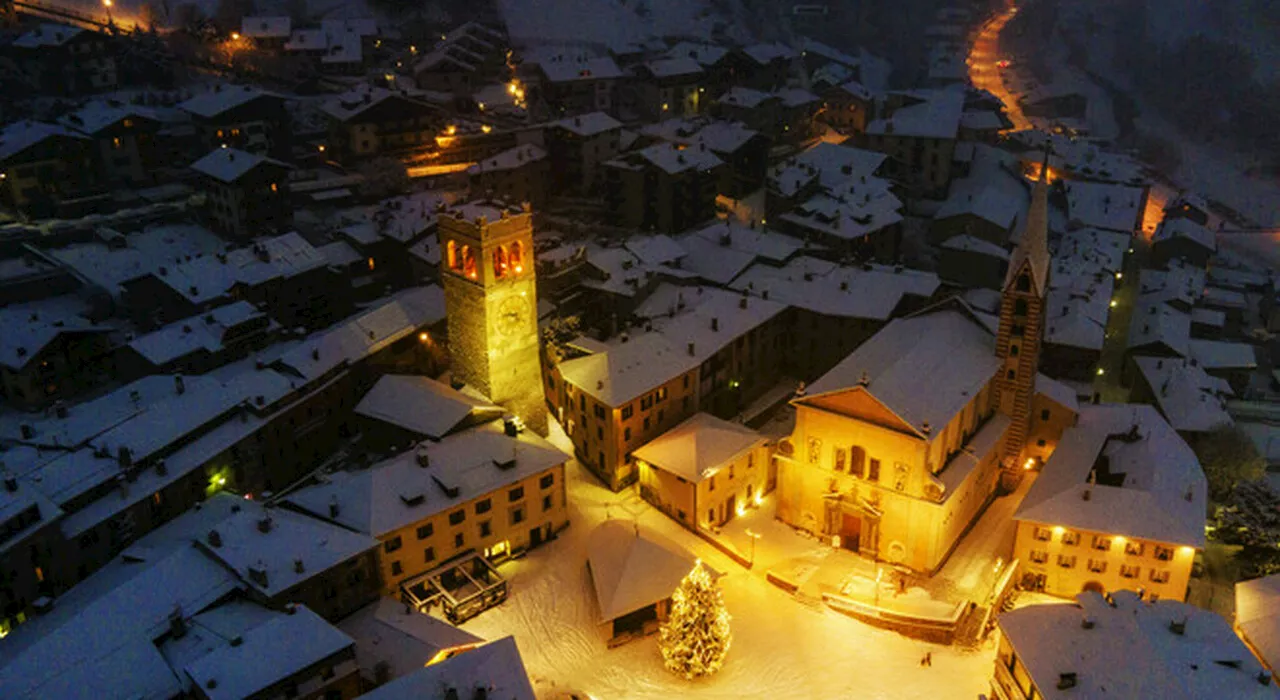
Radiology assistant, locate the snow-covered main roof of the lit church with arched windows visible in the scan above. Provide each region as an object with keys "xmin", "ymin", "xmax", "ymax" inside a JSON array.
[{"xmin": 797, "ymin": 302, "xmax": 1000, "ymax": 434}]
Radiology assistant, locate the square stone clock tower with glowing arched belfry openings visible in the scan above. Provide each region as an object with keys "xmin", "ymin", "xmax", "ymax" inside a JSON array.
[{"xmin": 439, "ymin": 201, "xmax": 547, "ymax": 435}]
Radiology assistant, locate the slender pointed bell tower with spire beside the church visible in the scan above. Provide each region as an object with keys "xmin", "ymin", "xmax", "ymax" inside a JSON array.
[{"xmin": 995, "ymin": 151, "xmax": 1050, "ymax": 470}]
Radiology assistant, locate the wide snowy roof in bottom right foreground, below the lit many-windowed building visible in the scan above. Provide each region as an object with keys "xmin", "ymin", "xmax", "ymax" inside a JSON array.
[{"xmin": 998, "ymin": 590, "xmax": 1276, "ymax": 700}]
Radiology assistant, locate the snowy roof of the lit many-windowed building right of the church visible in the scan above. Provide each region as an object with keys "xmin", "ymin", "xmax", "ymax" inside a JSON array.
[{"xmin": 1014, "ymin": 404, "xmax": 1207, "ymax": 548}]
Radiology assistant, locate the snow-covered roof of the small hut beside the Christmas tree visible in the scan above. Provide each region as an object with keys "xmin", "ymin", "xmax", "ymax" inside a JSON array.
[{"xmin": 586, "ymin": 520, "xmax": 698, "ymax": 622}]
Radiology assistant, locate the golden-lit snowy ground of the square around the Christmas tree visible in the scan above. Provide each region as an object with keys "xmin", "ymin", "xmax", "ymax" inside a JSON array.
[{"xmin": 463, "ymin": 427, "xmax": 993, "ymax": 700}]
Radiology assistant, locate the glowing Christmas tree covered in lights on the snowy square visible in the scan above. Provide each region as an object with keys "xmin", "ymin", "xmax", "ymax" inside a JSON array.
[{"xmin": 658, "ymin": 562, "xmax": 732, "ymax": 680}]
